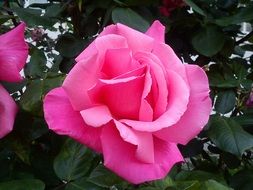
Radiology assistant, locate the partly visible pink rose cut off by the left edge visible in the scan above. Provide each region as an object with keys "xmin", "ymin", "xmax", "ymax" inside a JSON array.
[{"xmin": 0, "ymin": 23, "xmax": 28, "ymax": 138}]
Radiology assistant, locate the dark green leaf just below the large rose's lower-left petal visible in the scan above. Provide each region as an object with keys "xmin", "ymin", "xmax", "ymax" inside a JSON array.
[{"xmin": 54, "ymin": 139, "xmax": 94, "ymax": 182}]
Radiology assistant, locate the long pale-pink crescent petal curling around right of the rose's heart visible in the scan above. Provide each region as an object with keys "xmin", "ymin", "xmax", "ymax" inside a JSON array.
[{"xmin": 120, "ymin": 71, "xmax": 190, "ymax": 132}]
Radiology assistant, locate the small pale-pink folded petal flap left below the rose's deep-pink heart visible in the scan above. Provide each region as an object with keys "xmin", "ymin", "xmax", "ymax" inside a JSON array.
[{"xmin": 80, "ymin": 105, "xmax": 112, "ymax": 127}]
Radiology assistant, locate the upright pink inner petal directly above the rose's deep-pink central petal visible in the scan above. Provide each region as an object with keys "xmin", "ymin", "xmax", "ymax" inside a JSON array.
[{"xmin": 102, "ymin": 48, "xmax": 137, "ymax": 78}]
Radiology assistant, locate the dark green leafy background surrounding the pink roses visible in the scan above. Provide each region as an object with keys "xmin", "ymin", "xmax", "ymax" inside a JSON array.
[{"xmin": 0, "ymin": 0, "xmax": 253, "ymax": 190}]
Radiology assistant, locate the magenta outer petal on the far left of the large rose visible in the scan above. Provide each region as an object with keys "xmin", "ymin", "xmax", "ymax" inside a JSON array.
[{"xmin": 44, "ymin": 87, "xmax": 101, "ymax": 152}]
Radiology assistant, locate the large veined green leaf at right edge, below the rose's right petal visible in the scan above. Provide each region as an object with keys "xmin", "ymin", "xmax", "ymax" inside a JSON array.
[{"xmin": 208, "ymin": 116, "xmax": 253, "ymax": 156}]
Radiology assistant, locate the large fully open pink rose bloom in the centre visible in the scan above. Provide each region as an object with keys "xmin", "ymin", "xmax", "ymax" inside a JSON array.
[{"xmin": 44, "ymin": 21, "xmax": 211, "ymax": 184}]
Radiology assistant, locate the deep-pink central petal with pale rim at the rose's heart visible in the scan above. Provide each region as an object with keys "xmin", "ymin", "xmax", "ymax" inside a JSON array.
[{"xmin": 89, "ymin": 73, "xmax": 144, "ymax": 119}]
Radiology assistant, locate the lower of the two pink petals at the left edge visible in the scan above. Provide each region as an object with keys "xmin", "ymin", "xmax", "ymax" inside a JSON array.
[{"xmin": 0, "ymin": 85, "xmax": 18, "ymax": 138}]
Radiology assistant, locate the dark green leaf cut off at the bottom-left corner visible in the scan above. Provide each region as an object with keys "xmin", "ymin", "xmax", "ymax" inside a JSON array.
[{"xmin": 0, "ymin": 179, "xmax": 45, "ymax": 190}]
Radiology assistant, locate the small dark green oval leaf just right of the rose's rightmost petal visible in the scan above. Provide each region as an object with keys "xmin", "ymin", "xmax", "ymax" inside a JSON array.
[{"xmin": 215, "ymin": 90, "xmax": 236, "ymax": 114}]
